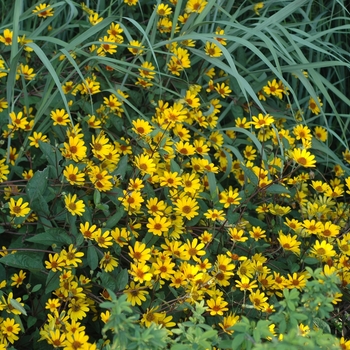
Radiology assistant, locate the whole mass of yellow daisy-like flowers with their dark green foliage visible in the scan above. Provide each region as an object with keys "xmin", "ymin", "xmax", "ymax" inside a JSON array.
[{"xmin": 0, "ymin": 0, "xmax": 350, "ymax": 350}]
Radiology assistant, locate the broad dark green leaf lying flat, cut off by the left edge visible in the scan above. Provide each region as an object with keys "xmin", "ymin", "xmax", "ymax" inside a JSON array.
[{"xmin": 0, "ymin": 251, "xmax": 44, "ymax": 271}]
